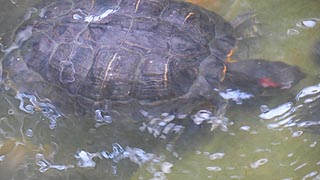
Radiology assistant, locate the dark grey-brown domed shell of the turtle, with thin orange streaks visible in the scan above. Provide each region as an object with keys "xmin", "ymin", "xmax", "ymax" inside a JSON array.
[{"xmin": 3, "ymin": 0, "xmax": 235, "ymax": 114}]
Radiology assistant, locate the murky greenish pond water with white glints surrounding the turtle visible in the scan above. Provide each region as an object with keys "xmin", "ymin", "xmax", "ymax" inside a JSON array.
[{"xmin": 0, "ymin": 0, "xmax": 320, "ymax": 180}]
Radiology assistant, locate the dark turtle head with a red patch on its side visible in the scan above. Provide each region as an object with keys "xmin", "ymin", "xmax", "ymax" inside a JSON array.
[{"xmin": 226, "ymin": 59, "xmax": 305, "ymax": 92}]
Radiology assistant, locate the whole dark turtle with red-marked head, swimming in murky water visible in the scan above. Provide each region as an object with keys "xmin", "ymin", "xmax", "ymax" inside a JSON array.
[{"xmin": 1, "ymin": 0, "xmax": 304, "ymax": 129}]
